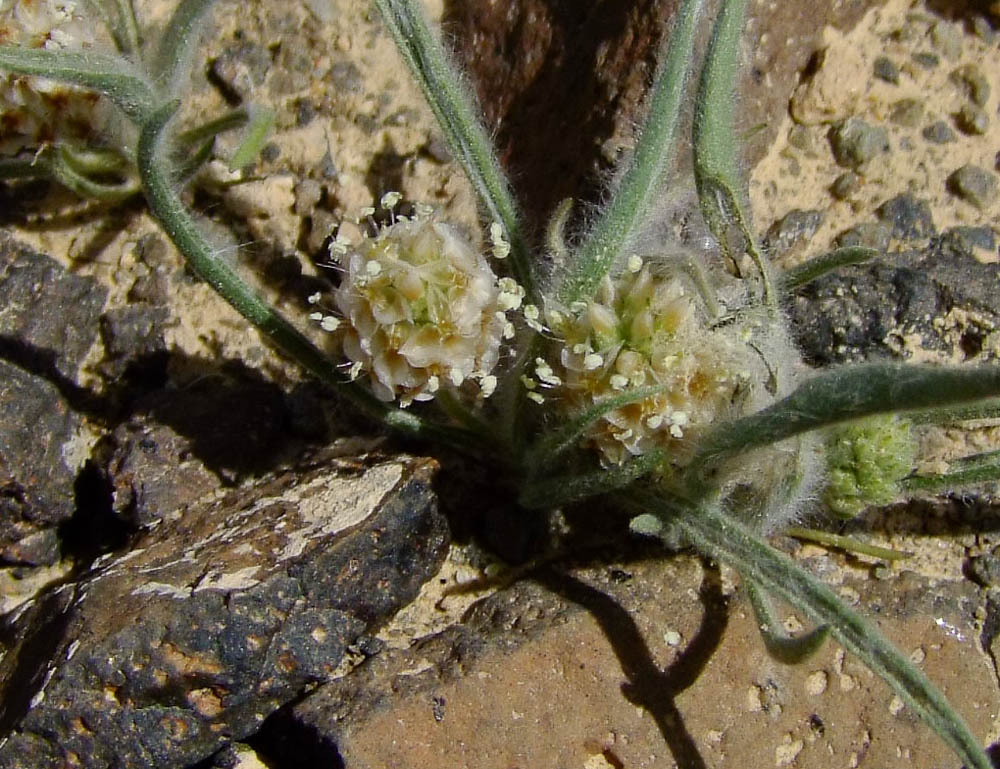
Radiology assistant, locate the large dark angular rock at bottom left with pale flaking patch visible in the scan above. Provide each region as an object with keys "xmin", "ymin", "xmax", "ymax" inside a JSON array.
[{"xmin": 0, "ymin": 456, "xmax": 448, "ymax": 769}]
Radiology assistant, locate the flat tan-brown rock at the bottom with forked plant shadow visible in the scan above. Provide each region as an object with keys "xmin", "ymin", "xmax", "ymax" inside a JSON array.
[{"xmin": 291, "ymin": 556, "xmax": 1000, "ymax": 769}]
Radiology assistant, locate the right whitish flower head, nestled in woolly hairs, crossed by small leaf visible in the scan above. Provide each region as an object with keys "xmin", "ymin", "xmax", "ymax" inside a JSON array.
[{"xmin": 552, "ymin": 257, "xmax": 755, "ymax": 466}]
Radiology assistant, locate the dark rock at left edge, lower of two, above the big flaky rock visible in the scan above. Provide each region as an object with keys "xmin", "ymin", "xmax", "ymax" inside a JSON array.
[{"xmin": 0, "ymin": 360, "xmax": 81, "ymax": 565}]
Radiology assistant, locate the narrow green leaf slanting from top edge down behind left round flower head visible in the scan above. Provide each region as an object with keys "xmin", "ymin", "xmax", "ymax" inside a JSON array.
[{"xmin": 375, "ymin": 0, "xmax": 542, "ymax": 307}]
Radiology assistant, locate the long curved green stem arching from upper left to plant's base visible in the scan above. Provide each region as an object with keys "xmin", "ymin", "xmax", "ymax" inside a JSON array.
[{"xmin": 137, "ymin": 102, "xmax": 482, "ymax": 449}]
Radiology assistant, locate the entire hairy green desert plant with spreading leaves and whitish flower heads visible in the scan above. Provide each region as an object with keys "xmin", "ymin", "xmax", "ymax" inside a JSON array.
[{"xmin": 0, "ymin": 0, "xmax": 1000, "ymax": 769}]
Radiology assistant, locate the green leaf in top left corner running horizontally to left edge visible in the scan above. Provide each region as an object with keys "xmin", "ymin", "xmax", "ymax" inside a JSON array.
[{"xmin": 0, "ymin": 45, "xmax": 156, "ymax": 124}]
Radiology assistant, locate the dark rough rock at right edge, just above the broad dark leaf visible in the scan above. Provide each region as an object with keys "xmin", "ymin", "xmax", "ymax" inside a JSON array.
[{"xmin": 789, "ymin": 237, "xmax": 1000, "ymax": 364}]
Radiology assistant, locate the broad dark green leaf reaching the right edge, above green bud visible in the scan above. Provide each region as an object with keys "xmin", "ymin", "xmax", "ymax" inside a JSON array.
[{"xmin": 691, "ymin": 363, "xmax": 1000, "ymax": 468}]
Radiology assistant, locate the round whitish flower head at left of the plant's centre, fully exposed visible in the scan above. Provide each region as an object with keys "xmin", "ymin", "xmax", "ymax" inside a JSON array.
[{"xmin": 333, "ymin": 210, "xmax": 523, "ymax": 405}]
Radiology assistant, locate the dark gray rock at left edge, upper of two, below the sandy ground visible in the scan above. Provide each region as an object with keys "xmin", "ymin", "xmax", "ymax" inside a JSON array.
[{"xmin": 0, "ymin": 234, "xmax": 107, "ymax": 382}]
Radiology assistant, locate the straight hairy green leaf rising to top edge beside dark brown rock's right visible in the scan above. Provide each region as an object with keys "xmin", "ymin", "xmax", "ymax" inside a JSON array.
[{"xmin": 558, "ymin": 0, "xmax": 704, "ymax": 306}]
